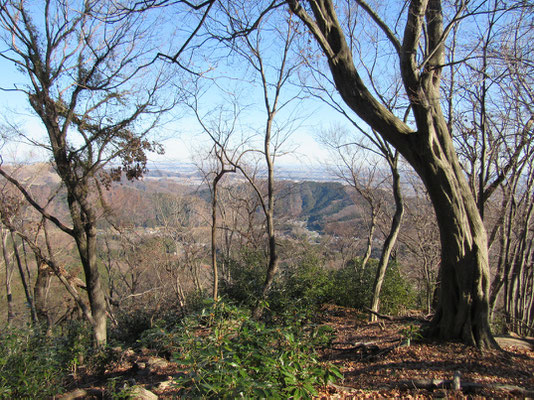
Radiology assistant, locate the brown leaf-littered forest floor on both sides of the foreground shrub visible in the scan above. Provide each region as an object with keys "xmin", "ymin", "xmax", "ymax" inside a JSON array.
[{"xmin": 63, "ymin": 306, "xmax": 534, "ymax": 399}]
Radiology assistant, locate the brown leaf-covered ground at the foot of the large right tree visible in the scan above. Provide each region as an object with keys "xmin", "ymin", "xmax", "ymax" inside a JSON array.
[{"xmin": 321, "ymin": 305, "xmax": 534, "ymax": 399}]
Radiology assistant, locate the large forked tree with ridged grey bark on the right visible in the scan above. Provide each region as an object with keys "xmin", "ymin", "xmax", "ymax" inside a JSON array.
[{"xmin": 289, "ymin": 0, "xmax": 498, "ymax": 348}]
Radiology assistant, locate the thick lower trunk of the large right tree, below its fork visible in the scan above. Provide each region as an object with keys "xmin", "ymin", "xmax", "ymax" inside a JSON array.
[{"xmin": 425, "ymin": 155, "xmax": 498, "ymax": 348}]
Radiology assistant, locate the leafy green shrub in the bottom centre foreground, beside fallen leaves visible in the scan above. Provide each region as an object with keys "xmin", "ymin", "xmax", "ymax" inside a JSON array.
[{"xmin": 175, "ymin": 302, "xmax": 342, "ymax": 398}]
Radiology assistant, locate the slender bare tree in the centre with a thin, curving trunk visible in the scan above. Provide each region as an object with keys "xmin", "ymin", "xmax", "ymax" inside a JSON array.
[{"xmin": 192, "ymin": 9, "xmax": 306, "ymax": 317}]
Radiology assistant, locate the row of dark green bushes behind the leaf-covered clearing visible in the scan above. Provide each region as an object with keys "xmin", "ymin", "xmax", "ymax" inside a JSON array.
[{"xmin": 221, "ymin": 249, "xmax": 415, "ymax": 318}]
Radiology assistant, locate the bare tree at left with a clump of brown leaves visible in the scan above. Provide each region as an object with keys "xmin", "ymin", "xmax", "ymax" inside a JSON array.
[{"xmin": 0, "ymin": 0, "xmax": 174, "ymax": 345}]
